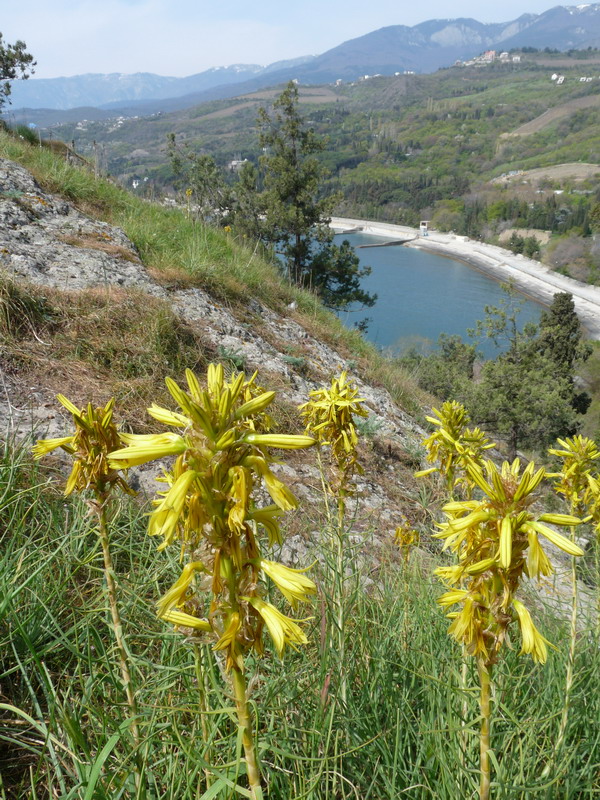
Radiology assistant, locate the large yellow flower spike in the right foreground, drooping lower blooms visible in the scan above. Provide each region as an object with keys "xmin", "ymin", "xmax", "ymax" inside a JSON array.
[{"xmin": 435, "ymin": 459, "xmax": 583, "ymax": 666}]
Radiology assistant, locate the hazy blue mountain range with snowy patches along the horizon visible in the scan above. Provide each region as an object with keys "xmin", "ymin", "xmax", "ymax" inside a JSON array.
[{"xmin": 11, "ymin": 3, "xmax": 600, "ymax": 118}]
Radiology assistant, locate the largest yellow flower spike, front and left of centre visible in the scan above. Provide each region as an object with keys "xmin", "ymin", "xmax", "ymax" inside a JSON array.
[{"xmin": 110, "ymin": 364, "xmax": 316, "ymax": 671}]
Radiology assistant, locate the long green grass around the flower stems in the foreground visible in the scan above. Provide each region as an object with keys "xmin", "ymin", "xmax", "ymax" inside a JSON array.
[{"xmin": 0, "ymin": 440, "xmax": 600, "ymax": 800}]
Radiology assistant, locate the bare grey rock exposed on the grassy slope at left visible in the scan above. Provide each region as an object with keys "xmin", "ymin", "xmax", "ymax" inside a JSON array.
[{"xmin": 0, "ymin": 160, "xmax": 423, "ymax": 548}]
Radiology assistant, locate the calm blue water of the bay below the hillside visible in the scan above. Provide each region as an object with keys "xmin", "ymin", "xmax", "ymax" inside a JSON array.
[{"xmin": 336, "ymin": 233, "xmax": 542, "ymax": 357}]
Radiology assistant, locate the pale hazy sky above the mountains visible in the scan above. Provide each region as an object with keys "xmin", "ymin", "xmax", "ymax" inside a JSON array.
[{"xmin": 0, "ymin": 0, "xmax": 574, "ymax": 78}]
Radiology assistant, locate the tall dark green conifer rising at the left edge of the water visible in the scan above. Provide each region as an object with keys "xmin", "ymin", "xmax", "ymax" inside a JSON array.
[{"xmin": 258, "ymin": 81, "xmax": 376, "ymax": 308}]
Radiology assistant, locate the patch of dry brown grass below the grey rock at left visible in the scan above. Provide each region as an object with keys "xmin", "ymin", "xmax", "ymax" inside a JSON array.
[{"xmin": 0, "ymin": 284, "xmax": 215, "ymax": 430}]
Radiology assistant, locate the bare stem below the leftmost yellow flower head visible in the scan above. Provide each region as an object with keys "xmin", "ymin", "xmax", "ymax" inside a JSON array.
[{"xmin": 96, "ymin": 504, "xmax": 142, "ymax": 797}]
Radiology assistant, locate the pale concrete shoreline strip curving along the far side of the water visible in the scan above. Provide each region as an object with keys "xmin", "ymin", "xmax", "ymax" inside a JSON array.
[{"xmin": 330, "ymin": 217, "xmax": 600, "ymax": 339}]
